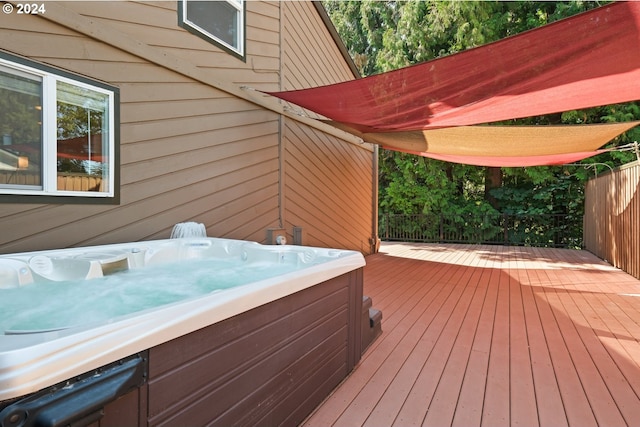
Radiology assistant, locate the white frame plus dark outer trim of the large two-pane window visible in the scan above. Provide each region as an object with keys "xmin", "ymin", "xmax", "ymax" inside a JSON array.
[{"xmin": 0, "ymin": 50, "xmax": 120, "ymax": 204}]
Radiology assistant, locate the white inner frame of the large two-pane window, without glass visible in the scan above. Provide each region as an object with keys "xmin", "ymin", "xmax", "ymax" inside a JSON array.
[{"xmin": 0, "ymin": 58, "xmax": 117, "ymax": 198}]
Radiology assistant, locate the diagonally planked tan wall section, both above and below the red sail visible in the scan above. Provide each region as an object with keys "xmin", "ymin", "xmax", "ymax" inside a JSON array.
[{"xmin": 282, "ymin": 2, "xmax": 377, "ymax": 252}]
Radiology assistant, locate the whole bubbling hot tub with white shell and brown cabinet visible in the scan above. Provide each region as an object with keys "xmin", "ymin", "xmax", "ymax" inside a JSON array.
[{"xmin": 0, "ymin": 238, "xmax": 364, "ymax": 426}]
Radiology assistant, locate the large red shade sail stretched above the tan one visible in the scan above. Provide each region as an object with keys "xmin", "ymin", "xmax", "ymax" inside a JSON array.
[{"xmin": 271, "ymin": 2, "xmax": 640, "ymax": 132}]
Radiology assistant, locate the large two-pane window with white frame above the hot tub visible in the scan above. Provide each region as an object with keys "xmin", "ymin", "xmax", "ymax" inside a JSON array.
[{"xmin": 0, "ymin": 54, "xmax": 119, "ymax": 203}]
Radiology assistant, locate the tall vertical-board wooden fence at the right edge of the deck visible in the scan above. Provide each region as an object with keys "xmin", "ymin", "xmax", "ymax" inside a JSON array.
[{"xmin": 584, "ymin": 161, "xmax": 640, "ymax": 279}]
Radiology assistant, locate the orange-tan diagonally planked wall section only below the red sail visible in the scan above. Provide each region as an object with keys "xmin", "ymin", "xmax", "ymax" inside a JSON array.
[{"xmin": 284, "ymin": 121, "xmax": 372, "ymax": 253}]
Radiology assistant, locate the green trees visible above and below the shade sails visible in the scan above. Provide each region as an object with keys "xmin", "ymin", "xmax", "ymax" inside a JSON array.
[{"xmin": 323, "ymin": 0, "xmax": 640, "ymax": 247}]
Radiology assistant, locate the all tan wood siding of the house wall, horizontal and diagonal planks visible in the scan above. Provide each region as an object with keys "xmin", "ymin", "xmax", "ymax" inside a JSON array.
[{"xmin": 0, "ymin": 2, "xmax": 374, "ymax": 253}]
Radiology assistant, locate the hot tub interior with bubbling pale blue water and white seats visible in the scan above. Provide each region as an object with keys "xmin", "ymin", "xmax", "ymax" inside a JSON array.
[{"xmin": 0, "ymin": 238, "xmax": 344, "ymax": 334}]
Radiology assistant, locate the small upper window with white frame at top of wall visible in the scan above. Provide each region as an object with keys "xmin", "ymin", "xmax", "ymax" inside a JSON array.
[{"xmin": 178, "ymin": 0, "xmax": 245, "ymax": 59}]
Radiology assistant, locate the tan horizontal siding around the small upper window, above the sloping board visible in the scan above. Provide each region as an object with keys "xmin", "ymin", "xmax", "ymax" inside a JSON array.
[{"xmin": 55, "ymin": 1, "xmax": 280, "ymax": 90}]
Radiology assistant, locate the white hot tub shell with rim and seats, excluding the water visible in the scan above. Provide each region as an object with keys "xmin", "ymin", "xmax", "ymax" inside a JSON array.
[{"xmin": 0, "ymin": 238, "xmax": 365, "ymax": 402}]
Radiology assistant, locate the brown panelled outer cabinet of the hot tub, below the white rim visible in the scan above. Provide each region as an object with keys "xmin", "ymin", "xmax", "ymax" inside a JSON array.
[{"xmin": 0, "ymin": 268, "xmax": 381, "ymax": 427}]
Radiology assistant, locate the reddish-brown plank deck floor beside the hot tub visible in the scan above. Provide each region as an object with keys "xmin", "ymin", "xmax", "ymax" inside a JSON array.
[{"xmin": 304, "ymin": 243, "xmax": 640, "ymax": 427}]
